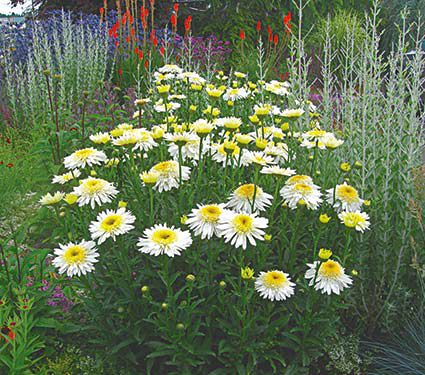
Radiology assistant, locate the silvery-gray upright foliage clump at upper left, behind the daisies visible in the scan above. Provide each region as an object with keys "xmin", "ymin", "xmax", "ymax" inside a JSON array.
[{"xmin": 0, "ymin": 12, "xmax": 114, "ymax": 127}]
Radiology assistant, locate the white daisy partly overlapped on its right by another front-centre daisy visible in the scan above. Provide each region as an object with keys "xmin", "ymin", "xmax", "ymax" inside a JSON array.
[{"xmin": 186, "ymin": 203, "xmax": 225, "ymax": 239}]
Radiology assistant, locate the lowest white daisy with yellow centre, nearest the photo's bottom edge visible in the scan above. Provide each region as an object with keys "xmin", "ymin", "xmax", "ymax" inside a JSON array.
[{"xmin": 255, "ymin": 270, "xmax": 295, "ymax": 301}]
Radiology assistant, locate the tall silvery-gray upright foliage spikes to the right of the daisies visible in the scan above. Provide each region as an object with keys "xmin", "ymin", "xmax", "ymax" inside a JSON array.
[{"xmin": 289, "ymin": 0, "xmax": 425, "ymax": 330}]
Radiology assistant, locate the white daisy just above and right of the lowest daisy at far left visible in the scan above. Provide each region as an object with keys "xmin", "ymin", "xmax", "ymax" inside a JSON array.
[{"xmin": 89, "ymin": 207, "xmax": 136, "ymax": 244}]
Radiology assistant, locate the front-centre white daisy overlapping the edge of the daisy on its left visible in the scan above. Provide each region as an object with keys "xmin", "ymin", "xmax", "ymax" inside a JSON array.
[{"xmin": 217, "ymin": 211, "xmax": 269, "ymax": 249}]
